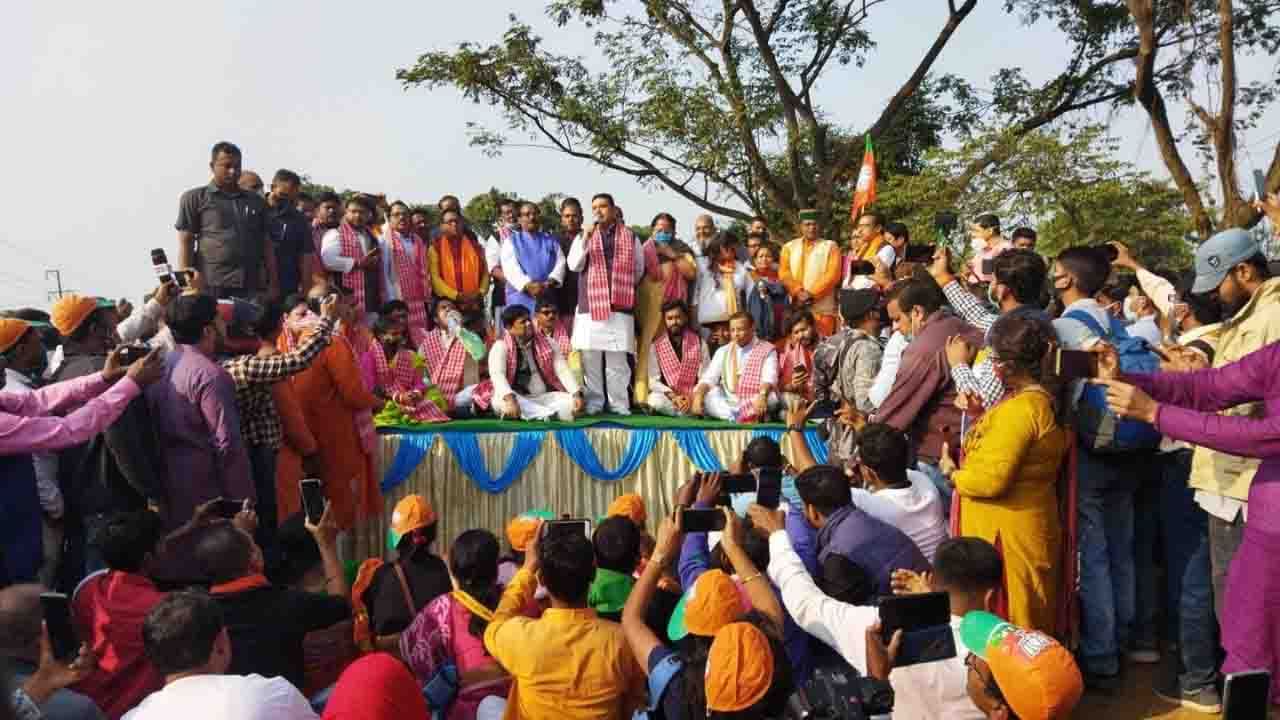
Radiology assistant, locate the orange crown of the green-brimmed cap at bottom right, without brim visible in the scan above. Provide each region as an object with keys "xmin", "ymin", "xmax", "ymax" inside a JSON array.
[{"xmin": 983, "ymin": 628, "xmax": 1084, "ymax": 720}]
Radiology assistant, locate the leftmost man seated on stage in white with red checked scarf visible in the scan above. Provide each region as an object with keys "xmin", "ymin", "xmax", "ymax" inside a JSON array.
[{"xmin": 419, "ymin": 297, "xmax": 485, "ymax": 418}]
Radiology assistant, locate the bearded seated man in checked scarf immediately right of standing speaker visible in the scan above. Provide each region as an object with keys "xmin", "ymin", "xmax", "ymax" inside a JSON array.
[{"xmin": 646, "ymin": 300, "xmax": 709, "ymax": 415}]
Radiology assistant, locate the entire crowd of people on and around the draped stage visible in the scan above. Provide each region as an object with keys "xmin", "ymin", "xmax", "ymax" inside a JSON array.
[{"xmin": 0, "ymin": 135, "xmax": 1280, "ymax": 720}]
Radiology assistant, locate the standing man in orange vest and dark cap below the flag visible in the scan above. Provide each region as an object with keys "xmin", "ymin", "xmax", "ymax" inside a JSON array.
[{"xmin": 778, "ymin": 210, "xmax": 840, "ymax": 337}]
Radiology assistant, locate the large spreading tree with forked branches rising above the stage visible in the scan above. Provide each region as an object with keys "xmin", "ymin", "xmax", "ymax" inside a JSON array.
[{"xmin": 397, "ymin": 0, "xmax": 1261, "ymax": 229}]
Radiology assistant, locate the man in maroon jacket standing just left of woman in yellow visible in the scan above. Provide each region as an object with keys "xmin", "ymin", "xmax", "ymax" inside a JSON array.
[{"xmin": 874, "ymin": 278, "xmax": 982, "ymax": 500}]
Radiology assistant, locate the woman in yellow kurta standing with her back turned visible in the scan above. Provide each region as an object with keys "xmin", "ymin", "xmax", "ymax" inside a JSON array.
[{"xmin": 943, "ymin": 316, "xmax": 1069, "ymax": 634}]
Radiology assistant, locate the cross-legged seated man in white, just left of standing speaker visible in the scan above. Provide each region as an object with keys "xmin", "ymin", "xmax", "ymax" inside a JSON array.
[{"xmin": 489, "ymin": 305, "xmax": 585, "ymax": 423}]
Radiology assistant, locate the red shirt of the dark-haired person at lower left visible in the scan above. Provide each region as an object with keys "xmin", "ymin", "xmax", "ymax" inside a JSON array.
[{"xmin": 72, "ymin": 570, "xmax": 165, "ymax": 720}]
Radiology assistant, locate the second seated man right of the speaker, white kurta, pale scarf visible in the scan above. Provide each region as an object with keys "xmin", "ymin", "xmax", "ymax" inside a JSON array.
[{"xmin": 691, "ymin": 311, "xmax": 782, "ymax": 423}]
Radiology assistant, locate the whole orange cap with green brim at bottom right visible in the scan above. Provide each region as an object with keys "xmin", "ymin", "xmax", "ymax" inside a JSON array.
[{"xmin": 960, "ymin": 611, "xmax": 1084, "ymax": 720}]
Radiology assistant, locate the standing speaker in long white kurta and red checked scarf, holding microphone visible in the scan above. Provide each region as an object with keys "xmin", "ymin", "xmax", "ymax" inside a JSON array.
[{"xmin": 568, "ymin": 192, "xmax": 644, "ymax": 415}]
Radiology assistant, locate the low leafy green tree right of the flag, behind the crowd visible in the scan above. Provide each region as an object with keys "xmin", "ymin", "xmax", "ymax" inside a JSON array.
[{"xmin": 877, "ymin": 126, "xmax": 1192, "ymax": 269}]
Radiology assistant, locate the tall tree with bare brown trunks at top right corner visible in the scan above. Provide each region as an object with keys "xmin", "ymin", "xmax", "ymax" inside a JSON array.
[{"xmin": 1126, "ymin": 0, "xmax": 1280, "ymax": 237}]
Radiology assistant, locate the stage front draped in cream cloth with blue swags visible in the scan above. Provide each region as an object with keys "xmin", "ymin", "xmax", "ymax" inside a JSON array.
[{"xmin": 357, "ymin": 415, "xmax": 826, "ymax": 555}]
